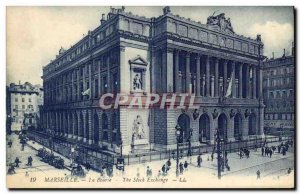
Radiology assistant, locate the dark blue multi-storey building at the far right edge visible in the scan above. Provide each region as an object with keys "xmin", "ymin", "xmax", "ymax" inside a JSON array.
[{"xmin": 263, "ymin": 51, "xmax": 295, "ymax": 131}]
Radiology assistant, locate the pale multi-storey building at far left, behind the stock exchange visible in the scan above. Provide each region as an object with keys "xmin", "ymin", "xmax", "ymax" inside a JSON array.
[{"xmin": 7, "ymin": 82, "xmax": 44, "ymax": 131}]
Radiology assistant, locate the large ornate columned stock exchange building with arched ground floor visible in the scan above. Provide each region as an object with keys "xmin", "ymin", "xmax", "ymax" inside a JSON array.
[{"xmin": 41, "ymin": 7, "xmax": 264, "ymax": 154}]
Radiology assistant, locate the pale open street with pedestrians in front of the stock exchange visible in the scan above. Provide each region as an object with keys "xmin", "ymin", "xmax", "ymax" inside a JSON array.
[{"xmin": 6, "ymin": 134, "xmax": 294, "ymax": 188}]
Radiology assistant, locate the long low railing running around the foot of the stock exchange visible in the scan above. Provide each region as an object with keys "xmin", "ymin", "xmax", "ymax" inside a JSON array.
[{"xmin": 28, "ymin": 131, "xmax": 294, "ymax": 170}]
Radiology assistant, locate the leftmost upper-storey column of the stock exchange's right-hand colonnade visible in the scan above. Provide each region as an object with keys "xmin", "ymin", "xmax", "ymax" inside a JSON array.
[{"xmin": 166, "ymin": 48, "xmax": 174, "ymax": 93}]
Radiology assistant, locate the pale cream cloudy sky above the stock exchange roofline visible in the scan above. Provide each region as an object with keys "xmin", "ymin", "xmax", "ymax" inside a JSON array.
[{"xmin": 6, "ymin": 6, "xmax": 294, "ymax": 85}]
